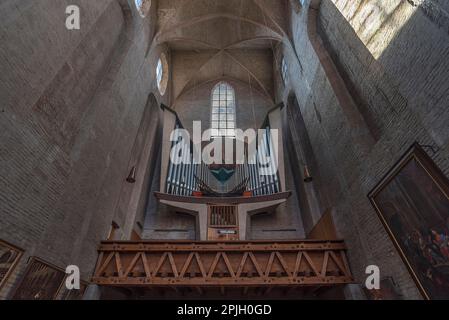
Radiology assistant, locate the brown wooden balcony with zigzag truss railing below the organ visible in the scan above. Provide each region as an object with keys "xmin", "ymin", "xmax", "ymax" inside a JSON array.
[{"xmin": 92, "ymin": 240, "xmax": 353, "ymax": 288}]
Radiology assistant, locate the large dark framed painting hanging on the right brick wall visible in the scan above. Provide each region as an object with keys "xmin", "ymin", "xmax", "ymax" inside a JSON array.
[{"xmin": 369, "ymin": 143, "xmax": 449, "ymax": 299}]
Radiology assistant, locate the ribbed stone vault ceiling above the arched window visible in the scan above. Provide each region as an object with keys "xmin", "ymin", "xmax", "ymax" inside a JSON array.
[{"xmin": 155, "ymin": 0, "xmax": 287, "ymax": 101}]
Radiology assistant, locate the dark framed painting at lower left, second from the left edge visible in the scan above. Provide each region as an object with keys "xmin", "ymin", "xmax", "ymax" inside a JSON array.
[{"xmin": 12, "ymin": 257, "xmax": 66, "ymax": 300}]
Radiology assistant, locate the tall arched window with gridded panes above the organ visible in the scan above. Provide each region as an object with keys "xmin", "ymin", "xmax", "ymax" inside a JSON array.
[{"xmin": 211, "ymin": 82, "xmax": 236, "ymax": 137}]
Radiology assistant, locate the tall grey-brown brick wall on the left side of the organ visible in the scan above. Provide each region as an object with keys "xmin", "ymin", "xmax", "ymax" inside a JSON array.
[{"xmin": 0, "ymin": 0, "xmax": 165, "ymax": 298}]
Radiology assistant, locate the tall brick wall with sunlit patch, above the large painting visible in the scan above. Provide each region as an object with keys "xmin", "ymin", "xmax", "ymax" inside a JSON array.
[{"xmin": 279, "ymin": 0, "xmax": 449, "ymax": 298}]
